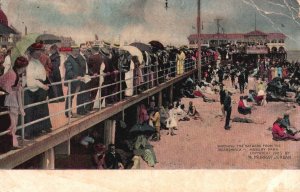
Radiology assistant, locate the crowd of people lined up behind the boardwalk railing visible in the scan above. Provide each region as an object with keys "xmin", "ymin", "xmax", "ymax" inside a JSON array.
[{"xmin": 0, "ymin": 41, "xmax": 220, "ymax": 154}]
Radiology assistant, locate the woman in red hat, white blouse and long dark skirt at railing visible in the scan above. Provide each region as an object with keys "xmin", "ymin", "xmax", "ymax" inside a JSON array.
[{"xmin": 24, "ymin": 43, "xmax": 52, "ymax": 139}]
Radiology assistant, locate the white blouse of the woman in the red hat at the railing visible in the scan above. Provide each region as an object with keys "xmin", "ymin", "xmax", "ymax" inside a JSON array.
[{"xmin": 26, "ymin": 58, "xmax": 46, "ymax": 92}]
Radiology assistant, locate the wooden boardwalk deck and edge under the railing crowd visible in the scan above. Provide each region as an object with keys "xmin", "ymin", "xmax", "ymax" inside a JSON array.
[{"xmin": 0, "ymin": 69, "xmax": 197, "ymax": 169}]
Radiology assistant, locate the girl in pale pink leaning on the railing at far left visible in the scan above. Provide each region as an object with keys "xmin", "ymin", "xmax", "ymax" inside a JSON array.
[{"xmin": 0, "ymin": 57, "xmax": 28, "ymax": 149}]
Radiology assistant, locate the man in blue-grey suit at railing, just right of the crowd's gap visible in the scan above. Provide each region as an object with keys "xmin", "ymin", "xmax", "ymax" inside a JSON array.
[{"xmin": 64, "ymin": 46, "xmax": 85, "ymax": 118}]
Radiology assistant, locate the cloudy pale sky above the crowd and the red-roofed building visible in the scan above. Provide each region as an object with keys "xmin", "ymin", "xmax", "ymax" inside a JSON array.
[{"xmin": 1, "ymin": 0, "xmax": 300, "ymax": 49}]
